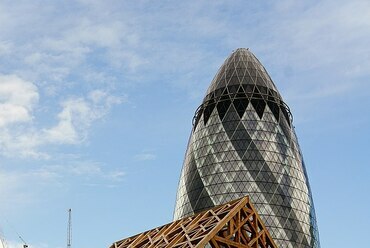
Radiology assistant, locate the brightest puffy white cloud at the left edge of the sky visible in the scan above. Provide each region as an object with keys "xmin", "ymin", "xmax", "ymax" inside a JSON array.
[{"xmin": 0, "ymin": 75, "xmax": 125, "ymax": 159}]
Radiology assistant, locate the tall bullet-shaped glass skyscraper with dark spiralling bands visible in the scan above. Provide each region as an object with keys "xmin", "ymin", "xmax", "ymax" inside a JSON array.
[{"xmin": 174, "ymin": 48, "xmax": 320, "ymax": 248}]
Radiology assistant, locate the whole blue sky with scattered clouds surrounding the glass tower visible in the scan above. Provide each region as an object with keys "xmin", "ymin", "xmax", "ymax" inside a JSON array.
[{"xmin": 0, "ymin": 0, "xmax": 370, "ymax": 248}]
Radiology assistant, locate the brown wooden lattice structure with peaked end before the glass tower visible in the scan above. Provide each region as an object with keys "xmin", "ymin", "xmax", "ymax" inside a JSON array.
[{"xmin": 110, "ymin": 197, "xmax": 277, "ymax": 248}]
